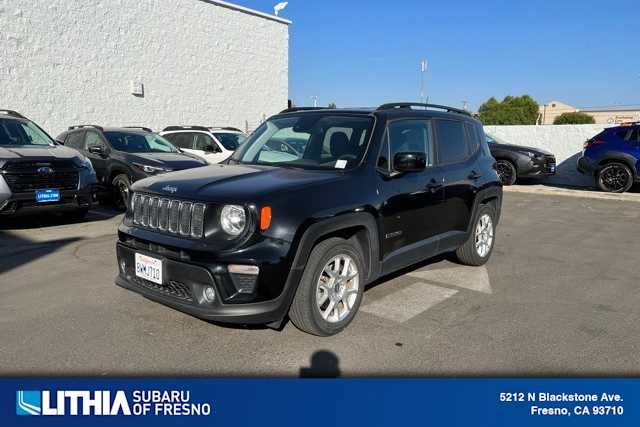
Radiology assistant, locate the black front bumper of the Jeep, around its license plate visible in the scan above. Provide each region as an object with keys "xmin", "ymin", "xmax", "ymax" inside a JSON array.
[{"xmin": 115, "ymin": 236, "xmax": 302, "ymax": 324}]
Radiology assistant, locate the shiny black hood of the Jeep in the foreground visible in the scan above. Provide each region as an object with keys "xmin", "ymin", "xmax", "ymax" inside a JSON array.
[{"xmin": 133, "ymin": 164, "xmax": 344, "ymax": 203}]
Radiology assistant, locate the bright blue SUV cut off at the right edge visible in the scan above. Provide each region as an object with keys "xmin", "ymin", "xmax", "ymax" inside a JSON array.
[{"xmin": 578, "ymin": 123, "xmax": 640, "ymax": 193}]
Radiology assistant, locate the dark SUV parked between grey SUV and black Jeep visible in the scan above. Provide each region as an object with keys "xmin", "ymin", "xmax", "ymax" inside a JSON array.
[{"xmin": 56, "ymin": 125, "xmax": 207, "ymax": 210}]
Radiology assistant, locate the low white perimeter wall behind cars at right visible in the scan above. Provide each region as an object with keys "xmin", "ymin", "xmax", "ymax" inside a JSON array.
[{"xmin": 484, "ymin": 125, "xmax": 607, "ymax": 187}]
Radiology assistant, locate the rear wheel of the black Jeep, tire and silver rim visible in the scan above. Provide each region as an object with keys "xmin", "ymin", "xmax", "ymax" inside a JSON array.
[{"xmin": 456, "ymin": 205, "xmax": 496, "ymax": 266}]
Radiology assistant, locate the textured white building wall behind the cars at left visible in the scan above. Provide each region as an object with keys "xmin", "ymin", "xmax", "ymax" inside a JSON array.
[{"xmin": 0, "ymin": 0, "xmax": 289, "ymax": 136}]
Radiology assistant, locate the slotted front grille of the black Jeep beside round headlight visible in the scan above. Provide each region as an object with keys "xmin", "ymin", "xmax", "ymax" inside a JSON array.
[{"xmin": 131, "ymin": 193, "xmax": 205, "ymax": 238}]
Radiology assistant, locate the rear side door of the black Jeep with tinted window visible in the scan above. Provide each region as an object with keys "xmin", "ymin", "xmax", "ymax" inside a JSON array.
[{"xmin": 434, "ymin": 119, "xmax": 480, "ymax": 239}]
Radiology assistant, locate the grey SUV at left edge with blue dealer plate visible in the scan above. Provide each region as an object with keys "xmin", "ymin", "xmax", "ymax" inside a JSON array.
[{"xmin": 0, "ymin": 110, "xmax": 96, "ymax": 219}]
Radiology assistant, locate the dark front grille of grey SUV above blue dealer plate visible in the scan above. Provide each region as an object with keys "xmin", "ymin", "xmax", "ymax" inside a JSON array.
[{"xmin": 2, "ymin": 161, "xmax": 79, "ymax": 193}]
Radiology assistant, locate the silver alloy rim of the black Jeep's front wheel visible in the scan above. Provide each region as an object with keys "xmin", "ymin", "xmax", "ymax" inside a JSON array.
[{"xmin": 316, "ymin": 254, "xmax": 360, "ymax": 323}]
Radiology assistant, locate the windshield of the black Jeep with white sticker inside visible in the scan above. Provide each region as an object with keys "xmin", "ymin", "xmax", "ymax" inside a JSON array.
[{"xmin": 232, "ymin": 113, "xmax": 373, "ymax": 169}]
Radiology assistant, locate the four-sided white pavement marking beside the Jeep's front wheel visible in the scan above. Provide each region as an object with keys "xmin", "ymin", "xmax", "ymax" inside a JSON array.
[{"xmin": 360, "ymin": 282, "xmax": 458, "ymax": 323}]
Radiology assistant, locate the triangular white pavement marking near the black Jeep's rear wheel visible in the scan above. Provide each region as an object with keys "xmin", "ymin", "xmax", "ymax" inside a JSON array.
[{"xmin": 408, "ymin": 267, "xmax": 492, "ymax": 294}]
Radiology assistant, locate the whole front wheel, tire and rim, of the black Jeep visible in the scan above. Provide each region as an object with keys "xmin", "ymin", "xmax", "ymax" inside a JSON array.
[{"xmin": 289, "ymin": 238, "xmax": 366, "ymax": 337}]
